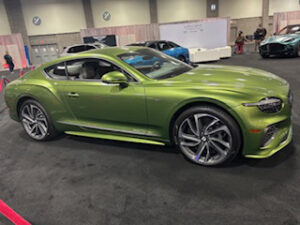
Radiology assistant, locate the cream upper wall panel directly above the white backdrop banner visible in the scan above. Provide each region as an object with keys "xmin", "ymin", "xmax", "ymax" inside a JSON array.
[{"xmin": 157, "ymin": 0, "xmax": 206, "ymax": 23}]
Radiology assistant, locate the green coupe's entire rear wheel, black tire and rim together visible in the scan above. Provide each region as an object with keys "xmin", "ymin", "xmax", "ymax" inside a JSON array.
[{"xmin": 19, "ymin": 99, "xmax": 58, "ymax": 141}]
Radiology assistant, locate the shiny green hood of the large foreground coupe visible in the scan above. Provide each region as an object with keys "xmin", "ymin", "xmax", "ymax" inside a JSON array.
[{"xmin": 168, "ymin": 65, "xmax": 289, "ymax": 97}]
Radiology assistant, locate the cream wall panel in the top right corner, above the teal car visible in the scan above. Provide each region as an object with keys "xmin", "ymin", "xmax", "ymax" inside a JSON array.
[{"xmin": 269, "ymin": 0, "xmax": 300, "ymax": 16}]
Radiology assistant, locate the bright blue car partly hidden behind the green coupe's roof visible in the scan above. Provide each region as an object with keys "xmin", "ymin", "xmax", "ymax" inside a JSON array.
[{"xmin": 128, "ymin": 41, "xmax": 190, "ymax": 63}]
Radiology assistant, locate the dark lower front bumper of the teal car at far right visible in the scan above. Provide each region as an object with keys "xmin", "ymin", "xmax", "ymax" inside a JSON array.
[{"xmin": 259, "ymin": 43, "xmax": 295, "ymax": 56}]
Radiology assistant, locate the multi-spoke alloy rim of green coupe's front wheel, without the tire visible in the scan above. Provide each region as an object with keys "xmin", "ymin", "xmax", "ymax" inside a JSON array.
[{"xmin": 178, "ymin": 113, "xmax": 232, "ymax": 165}]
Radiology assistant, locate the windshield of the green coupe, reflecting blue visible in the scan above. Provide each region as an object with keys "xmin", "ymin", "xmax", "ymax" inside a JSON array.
[{"xmin": 118, "ymin": 48, "xmax": 193, "ymax": 79}]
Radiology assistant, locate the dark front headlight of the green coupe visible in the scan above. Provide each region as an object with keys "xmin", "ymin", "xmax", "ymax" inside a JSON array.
[{"xmin": 243, "ymin": 97, "xmax": 282, "ymax": 113}]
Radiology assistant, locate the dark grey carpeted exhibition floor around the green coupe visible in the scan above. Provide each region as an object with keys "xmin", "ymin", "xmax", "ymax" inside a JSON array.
[{"xmin": 0, "ymin": 54, "xmax": 300, "ymax": 225}]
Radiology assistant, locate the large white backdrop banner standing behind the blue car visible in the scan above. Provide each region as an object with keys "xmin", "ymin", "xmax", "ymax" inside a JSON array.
[{"xmin": 159, "ymin": 18, "xmax": 229, "ymax": 49}]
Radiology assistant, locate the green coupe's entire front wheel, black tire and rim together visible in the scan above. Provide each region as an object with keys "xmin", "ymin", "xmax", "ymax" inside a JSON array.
[{"xmin": 173, "ymin": 106, "xmax": 242, "ymax": 166}]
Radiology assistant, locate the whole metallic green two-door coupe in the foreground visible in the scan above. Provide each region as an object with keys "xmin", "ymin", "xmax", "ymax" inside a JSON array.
[{"xmin": 5, "ymin": 47, "xmax": 292, "ymax": 166}]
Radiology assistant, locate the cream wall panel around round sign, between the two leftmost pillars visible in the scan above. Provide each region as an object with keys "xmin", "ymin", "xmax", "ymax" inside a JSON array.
[{"xmin": 21, "ymin": 0, "xmax": 86, "ymax": 35}]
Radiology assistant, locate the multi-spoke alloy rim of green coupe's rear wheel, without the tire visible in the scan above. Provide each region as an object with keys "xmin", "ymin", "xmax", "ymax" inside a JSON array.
[{"xmin": 21, "ymin": 104, "xmax": 49, "ymax": 140}]
